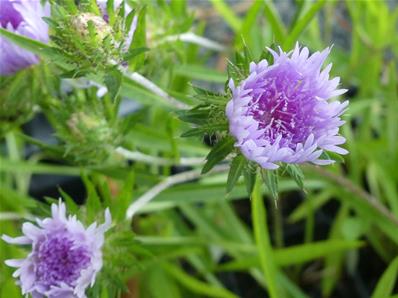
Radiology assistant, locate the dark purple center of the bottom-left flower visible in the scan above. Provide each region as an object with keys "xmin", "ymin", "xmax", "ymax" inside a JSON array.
[{"xmin": 35, "ymin": 230, "xmax": 91, "ymax": 287}]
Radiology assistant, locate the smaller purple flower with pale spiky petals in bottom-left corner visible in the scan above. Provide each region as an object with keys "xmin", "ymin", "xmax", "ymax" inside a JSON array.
[{"xmin": 2, "ymin": 201, "xmax": 111, "ymax": 298}]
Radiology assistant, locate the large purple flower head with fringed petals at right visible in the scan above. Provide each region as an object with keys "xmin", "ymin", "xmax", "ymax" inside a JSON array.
[{"xmin": 226, "ymin": 44, "xmax": 348, "ymax": 169}]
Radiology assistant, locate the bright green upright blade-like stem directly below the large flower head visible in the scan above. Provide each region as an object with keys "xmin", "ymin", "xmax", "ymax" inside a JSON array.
[{"xmin": 251, "ymin": 175, "xmax": 282, "ymax": 298}]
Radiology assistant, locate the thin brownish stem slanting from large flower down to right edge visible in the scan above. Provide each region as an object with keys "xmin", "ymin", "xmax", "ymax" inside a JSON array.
[{"xmin": 305, "ymin": 166, "xmax": 398, "ymax": 226}]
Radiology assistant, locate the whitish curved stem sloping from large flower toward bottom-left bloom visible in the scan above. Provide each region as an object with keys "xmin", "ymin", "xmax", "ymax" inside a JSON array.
[{"xmin": 126, "ymin": 165, "xmax": 229, "ymax": 220}]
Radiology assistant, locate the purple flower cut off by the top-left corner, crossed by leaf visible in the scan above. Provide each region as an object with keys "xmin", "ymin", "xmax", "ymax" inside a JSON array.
[{"xmin": 0, "ymin": 0, "xmax": 50, "ymax": 75}]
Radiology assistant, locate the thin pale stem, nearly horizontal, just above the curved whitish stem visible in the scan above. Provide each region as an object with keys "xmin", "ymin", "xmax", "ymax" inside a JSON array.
[{"xmin": 116, "ymin": 147, "xmax": 204, "ymax": 166}]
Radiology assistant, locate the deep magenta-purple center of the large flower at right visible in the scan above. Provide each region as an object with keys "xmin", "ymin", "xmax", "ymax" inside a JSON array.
[{"xmin": 247, "ymin": 72, "xmax": 313, "ymax": 149}]
